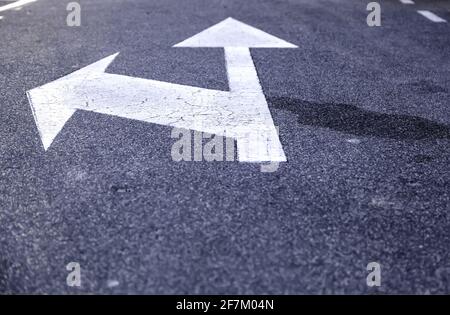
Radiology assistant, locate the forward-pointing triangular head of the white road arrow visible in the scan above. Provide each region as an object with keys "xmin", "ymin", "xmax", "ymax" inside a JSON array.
[{"xmin": 173, "ymin": 17, "xmax": 297, "ymax": 48}]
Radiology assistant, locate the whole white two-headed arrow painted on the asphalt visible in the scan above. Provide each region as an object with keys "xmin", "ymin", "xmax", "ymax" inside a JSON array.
[{"xmin": 27, "ymin": 18, "xmax": 297, "ymax": 162}]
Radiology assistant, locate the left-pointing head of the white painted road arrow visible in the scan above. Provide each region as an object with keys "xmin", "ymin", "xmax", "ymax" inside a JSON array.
[{"xmin": 27, "ymin": 53, "xmax": 118, "ymax": 150}]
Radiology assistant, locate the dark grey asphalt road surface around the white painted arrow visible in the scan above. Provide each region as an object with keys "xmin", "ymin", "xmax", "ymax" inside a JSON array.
[{"xmin": 0, "ymin": 0, "xmax": 450, "ymax": 294}]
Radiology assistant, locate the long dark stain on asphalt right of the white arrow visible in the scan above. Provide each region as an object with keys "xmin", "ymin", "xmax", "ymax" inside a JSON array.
[{"xmin": 269, "ymin": 98, "xmax": 450, "ymax": 140}]
